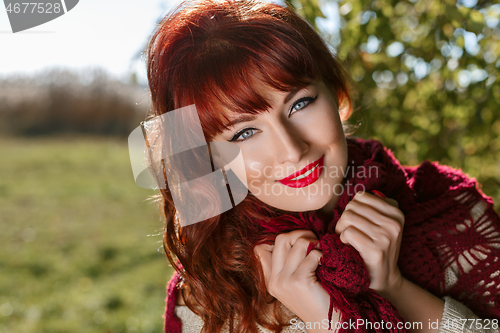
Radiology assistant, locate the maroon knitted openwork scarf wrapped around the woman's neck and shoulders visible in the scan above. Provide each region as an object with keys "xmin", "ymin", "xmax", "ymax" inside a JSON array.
[{"xmin": 165, "ymin": 138, "xmax": 500, "ymax": 333}]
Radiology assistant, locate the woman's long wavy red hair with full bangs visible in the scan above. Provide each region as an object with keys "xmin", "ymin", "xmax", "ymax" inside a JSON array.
[{"xmin": 147, "ymin": 0, "xmax": 352, "ymax": 333}]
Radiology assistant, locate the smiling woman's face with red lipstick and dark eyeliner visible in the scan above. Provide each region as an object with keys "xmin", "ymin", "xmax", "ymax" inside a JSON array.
[{"xmin": 213, "ymin": 83, "xmax": 347, "ymax": 212}]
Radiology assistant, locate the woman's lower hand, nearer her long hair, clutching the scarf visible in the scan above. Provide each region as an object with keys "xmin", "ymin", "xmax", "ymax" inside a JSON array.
[{"xmin": 254, "ymin": 230, "xmax": 335, "ymax": 322}]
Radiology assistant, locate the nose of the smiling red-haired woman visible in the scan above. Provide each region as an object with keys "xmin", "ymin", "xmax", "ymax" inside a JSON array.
[{"xmin": 274, "ymin": 120, "xmax": 309, "ymax": 164}]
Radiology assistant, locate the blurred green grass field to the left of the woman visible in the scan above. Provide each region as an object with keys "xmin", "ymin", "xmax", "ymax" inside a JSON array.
[{"xmin": 0, "ymin": 137, "xmax": 172, "ymax": 333}]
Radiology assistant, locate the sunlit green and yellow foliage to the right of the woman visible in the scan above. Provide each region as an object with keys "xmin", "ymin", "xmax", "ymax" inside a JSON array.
[{"xmin": 296, "ymin": 0, "xmax": 500, "ymax": 209}]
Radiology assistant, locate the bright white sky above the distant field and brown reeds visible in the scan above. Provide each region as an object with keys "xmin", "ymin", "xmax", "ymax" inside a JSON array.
[{"xmin": 0, "ymin": 0, "xmax": 337, "ymax": 85}]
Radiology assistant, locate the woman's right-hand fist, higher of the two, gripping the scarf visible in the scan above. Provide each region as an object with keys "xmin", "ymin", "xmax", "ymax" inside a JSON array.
[{"xmin": 335, "ymin": 192, "xmax": 405, "ymax": 297}]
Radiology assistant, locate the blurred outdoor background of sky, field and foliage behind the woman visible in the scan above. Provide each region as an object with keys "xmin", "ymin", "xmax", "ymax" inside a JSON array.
[{"xmin": 0, "ymin": 0, "xmax": 500, "ymax": 333}]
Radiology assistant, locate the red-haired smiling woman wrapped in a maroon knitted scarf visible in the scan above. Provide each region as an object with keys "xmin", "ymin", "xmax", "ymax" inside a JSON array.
[{"xmin": 143, "ymin": 0, "xmax": 500, "ymax": 332}]
